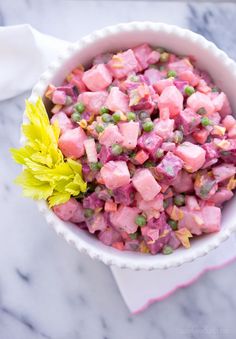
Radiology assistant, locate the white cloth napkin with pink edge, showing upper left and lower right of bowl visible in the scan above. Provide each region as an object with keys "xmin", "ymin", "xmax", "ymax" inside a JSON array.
[{"xmin": 0, "ymin": 25, "xmax": 236, "ymax": 313}]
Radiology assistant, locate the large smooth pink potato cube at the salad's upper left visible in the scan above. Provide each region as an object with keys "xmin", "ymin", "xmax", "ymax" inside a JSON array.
[{"xmin": 82, "ymin": 64, "xmax": 112, "ymax": 92}]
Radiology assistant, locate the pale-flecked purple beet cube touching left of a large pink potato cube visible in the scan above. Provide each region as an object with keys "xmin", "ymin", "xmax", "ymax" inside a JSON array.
[{"xmin": 156, "ymin": 152, "xmax": 183, "ymax": 179}]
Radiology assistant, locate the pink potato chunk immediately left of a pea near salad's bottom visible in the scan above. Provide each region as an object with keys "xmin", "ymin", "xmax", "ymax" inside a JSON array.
[{"xmin": 110, "ymin": 205, "xmax": 139, "ymax": 234}]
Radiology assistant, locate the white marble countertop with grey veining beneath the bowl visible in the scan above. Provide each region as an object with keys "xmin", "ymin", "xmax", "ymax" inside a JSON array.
[{"xmin": 0, "ymin": 0, "xmax": 236, "ymax": 339}]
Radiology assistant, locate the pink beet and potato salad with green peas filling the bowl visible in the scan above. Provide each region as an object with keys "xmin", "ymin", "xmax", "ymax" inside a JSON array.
[{"xmin": 46, "ymin": 44, "xmax": 236, "ymax": 254}]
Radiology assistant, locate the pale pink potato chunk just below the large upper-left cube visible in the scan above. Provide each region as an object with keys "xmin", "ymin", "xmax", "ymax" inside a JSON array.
[{"xmin": 78, "ymin": 91, "xmax": 108, "ymax": 113}]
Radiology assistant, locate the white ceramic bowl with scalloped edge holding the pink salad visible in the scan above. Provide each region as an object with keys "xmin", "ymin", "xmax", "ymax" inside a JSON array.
[{"xmin": 30, "ymin": 22, "xmax": 236, "ymax": 270}]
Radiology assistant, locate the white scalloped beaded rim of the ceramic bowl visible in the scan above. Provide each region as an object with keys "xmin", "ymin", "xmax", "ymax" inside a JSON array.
[{"xmin": 21, "ymin": 22, "xmax": 236, "ymax": 270}]
